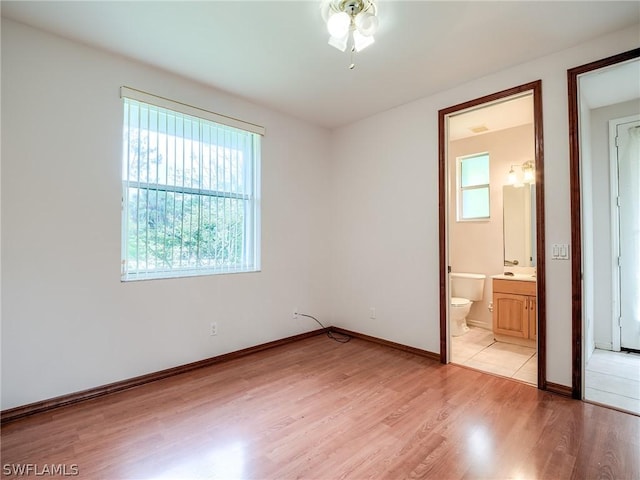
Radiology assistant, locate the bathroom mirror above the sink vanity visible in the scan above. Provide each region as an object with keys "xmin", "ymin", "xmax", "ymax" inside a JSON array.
[{"xmin": 502, "ymin": 184, "xmax": 536, "ymax": 267}]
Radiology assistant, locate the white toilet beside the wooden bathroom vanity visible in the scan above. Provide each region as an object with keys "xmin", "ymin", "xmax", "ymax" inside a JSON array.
[{"xmin": 449, "ymin": 273, "xmax": 486, "ymax": 337}]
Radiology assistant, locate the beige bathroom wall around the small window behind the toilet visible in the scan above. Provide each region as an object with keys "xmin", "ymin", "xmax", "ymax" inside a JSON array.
[{"xmin": 448, "ymin": 124, "xmax": 535, "ymax": 329}]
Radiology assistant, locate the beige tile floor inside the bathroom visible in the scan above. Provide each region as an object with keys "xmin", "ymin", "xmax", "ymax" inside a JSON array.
[{"xmin": 450, "ymin": 327, "xmax": 538, "ymax": 386}]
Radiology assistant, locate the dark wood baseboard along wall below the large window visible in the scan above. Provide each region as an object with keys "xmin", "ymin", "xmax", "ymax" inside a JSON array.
[{"xmin": 0, "ymin": 329, "xmax": 327, "ymax": 424}]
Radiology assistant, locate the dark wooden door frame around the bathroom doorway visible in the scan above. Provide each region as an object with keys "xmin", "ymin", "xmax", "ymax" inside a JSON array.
[{"xmin": 438, "ymin": 80, "xmax": 547, "ymax": 390}]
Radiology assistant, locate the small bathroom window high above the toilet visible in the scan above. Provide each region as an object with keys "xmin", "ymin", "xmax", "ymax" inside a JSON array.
[{"xmin": 458, "ymin": 153, "xmax": 490, "ymax": 222}]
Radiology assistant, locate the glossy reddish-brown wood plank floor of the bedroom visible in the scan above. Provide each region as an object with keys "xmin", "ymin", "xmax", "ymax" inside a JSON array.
[{"xmin": 1, "ymin": 336, "xmax": 640, "ymax": 480}]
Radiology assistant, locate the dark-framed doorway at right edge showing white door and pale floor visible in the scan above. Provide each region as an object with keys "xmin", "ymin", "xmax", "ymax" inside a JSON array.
[{"xmin": 567, "ymin": 49, "xmax": 640, "ymax": 415}]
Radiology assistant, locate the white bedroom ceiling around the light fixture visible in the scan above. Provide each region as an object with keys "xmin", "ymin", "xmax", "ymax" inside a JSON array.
[{"xmin": 2, "ymin": 0, "xmax": 640, "ymax": 128}]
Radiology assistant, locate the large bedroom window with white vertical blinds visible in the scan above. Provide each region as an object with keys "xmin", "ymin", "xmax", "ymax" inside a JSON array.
[{"xmin": 122, "ymin": 87, "xmax": 264, "ymax": 281}]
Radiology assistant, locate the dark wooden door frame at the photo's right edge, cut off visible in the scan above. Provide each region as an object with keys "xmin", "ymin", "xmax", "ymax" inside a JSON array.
[{"xmin": 567, "ymin": 48, "xmax": 640, "ymax": 400}]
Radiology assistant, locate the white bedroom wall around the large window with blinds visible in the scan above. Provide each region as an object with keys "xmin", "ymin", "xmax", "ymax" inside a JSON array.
[{"xmin": 1, "ymin": 19, "xmax": 330, "ymax": 409}]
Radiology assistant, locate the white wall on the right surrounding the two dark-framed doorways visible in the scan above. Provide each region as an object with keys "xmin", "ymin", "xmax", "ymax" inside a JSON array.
[{"xmin": 332, "ymin": 27, "xmax": 638, "ymax": 386}]
